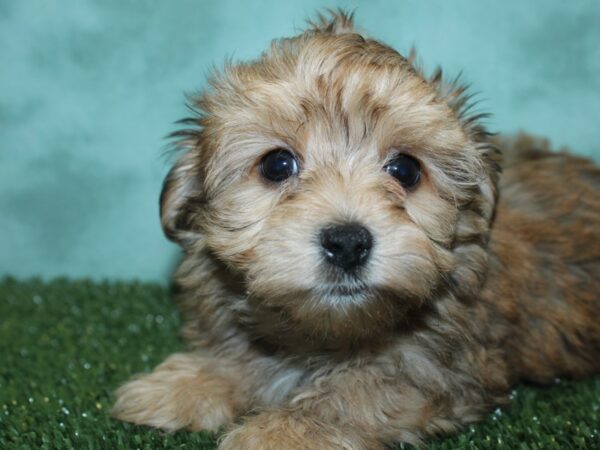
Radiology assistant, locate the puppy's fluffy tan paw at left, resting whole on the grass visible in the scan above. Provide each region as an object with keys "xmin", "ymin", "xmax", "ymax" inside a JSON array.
[{"xmin": 111, "ymin": 354, "xmax": 240, "ymax": 431}]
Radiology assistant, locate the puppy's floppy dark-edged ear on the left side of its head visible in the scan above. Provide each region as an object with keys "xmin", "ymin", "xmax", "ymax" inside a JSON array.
[{"xmin": 160, "ymin": 151, "xmax": 205, "ymax": 248}]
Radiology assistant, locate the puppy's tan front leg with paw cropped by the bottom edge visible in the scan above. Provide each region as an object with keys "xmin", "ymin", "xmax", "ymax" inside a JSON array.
[{"xmin": 219, "ymin": 364, "xmax": 489, "ymax": 450}]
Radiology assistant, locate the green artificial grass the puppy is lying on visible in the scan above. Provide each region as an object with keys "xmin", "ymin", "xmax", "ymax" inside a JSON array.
[{"xmin": 0, "ymin": 278, "xmax": 600, "ymax": 450}]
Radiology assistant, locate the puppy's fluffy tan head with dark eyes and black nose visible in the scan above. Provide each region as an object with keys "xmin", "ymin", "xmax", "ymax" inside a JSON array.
[{"xmin": 161, "ymin": 9, "xmax": 496, "ymax": 345}]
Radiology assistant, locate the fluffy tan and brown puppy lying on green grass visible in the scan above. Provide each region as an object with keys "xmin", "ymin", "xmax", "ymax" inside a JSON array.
[{"xmin": 113, "ymin": 12, "xmax": 600, "ymax": 449}]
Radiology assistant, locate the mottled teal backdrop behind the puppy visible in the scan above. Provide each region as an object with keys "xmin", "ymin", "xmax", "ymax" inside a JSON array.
[{"xmin": 0, "ymin": 0, "xmax": 600, "ymax": 282}]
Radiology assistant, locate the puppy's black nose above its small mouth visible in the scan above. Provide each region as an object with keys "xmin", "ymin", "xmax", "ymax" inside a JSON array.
[{"xmin": 321, "ymin": 223, "xmax": 373, "ymax": 270}]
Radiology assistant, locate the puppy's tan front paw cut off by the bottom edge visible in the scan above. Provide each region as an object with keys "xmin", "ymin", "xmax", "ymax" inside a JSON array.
[{"xmin": 219, "ymin": 411, "xmax": 384, "ymax": 450}]
